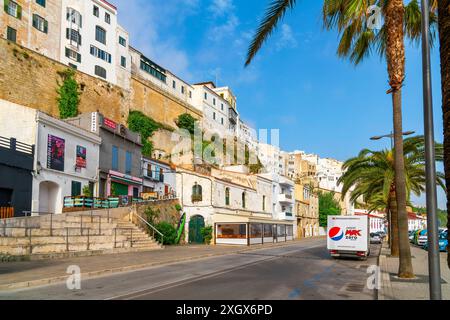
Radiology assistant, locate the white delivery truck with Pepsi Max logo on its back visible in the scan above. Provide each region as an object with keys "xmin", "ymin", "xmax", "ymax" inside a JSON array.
[{"xmin": 327, "ymin": 216, "xmax": 370, "ymax": 259}]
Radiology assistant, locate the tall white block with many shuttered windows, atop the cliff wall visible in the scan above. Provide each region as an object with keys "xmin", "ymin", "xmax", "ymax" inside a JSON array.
[{"xmin": 60, "ymin": 0, "xmax": 131, "ymax": 88}]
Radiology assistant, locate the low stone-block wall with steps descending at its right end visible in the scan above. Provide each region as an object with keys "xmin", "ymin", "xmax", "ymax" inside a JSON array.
[{"xmin": 0, "ymin": 207, "xmax": 162, "ymax": 260}]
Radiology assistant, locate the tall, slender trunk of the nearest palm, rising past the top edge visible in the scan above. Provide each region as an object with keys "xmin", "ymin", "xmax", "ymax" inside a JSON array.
[{"xmin": 386, "ymin": 0, "xmax": 414, "ymax": 278}]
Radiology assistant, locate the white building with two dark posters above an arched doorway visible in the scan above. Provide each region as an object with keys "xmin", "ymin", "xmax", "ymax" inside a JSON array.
[{"xmin": 0, "ymin": 100, "xmax": 101, "ymax": 215}]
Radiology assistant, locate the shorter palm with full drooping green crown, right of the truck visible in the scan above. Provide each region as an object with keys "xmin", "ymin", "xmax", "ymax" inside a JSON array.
[{"xmin": 339, "ymin": 136, "xmax": 445, "ymax": 256}]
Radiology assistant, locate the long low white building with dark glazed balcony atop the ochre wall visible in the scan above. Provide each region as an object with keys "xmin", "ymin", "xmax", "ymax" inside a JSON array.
[{"xmin": 129, "ymin": 47, "xmax": 195, "ymax": 110}]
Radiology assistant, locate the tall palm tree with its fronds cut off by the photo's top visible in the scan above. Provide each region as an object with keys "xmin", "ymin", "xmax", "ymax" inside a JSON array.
[{"xmin": 245, "ymin": 0, "xmax": 436, "ymax": 278}]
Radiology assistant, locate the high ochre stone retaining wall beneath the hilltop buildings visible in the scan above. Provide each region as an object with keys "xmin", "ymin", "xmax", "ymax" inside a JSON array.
[{"xmin": 0, "ymin": 39, "xmax": 202, "ymax": 153}]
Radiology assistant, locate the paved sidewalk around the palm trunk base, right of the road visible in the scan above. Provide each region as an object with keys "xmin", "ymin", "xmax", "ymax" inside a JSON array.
[{"xmin": 378, "ymin": 243, "xmax": 450, "ymax": 300}]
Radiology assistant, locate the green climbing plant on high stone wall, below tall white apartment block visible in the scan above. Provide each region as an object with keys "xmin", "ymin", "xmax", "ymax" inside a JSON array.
[{"xmin": 56, "ymin": 69, "xmax": 80, "ymax": 119}]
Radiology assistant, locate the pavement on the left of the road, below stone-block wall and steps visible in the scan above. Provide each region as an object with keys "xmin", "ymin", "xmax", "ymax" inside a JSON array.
[{"xmin": 0, "ymin": 238, "xmax": 324, "ymax": 291}]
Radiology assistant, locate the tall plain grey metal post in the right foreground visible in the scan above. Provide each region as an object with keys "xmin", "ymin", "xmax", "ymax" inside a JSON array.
[{"xmin": 421, "ymin": 0, "xmax": 442, "ymax": 300}]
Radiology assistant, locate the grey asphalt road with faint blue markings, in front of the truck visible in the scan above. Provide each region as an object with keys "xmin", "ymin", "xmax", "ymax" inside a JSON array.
[{"xmin": 0, "ymin": 239, "xmax": 380, "ymax": 300}]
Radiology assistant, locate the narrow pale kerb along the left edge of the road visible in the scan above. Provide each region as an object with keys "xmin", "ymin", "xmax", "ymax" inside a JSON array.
[{"xmin": 0, "ymin": 237, "xmax": 321, "ymax": 291}]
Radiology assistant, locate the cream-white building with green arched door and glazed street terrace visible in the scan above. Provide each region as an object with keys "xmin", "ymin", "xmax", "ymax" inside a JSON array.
[{"xmin": 176, "ymin": 169, "xmax": 295, "ymax": 245}]
